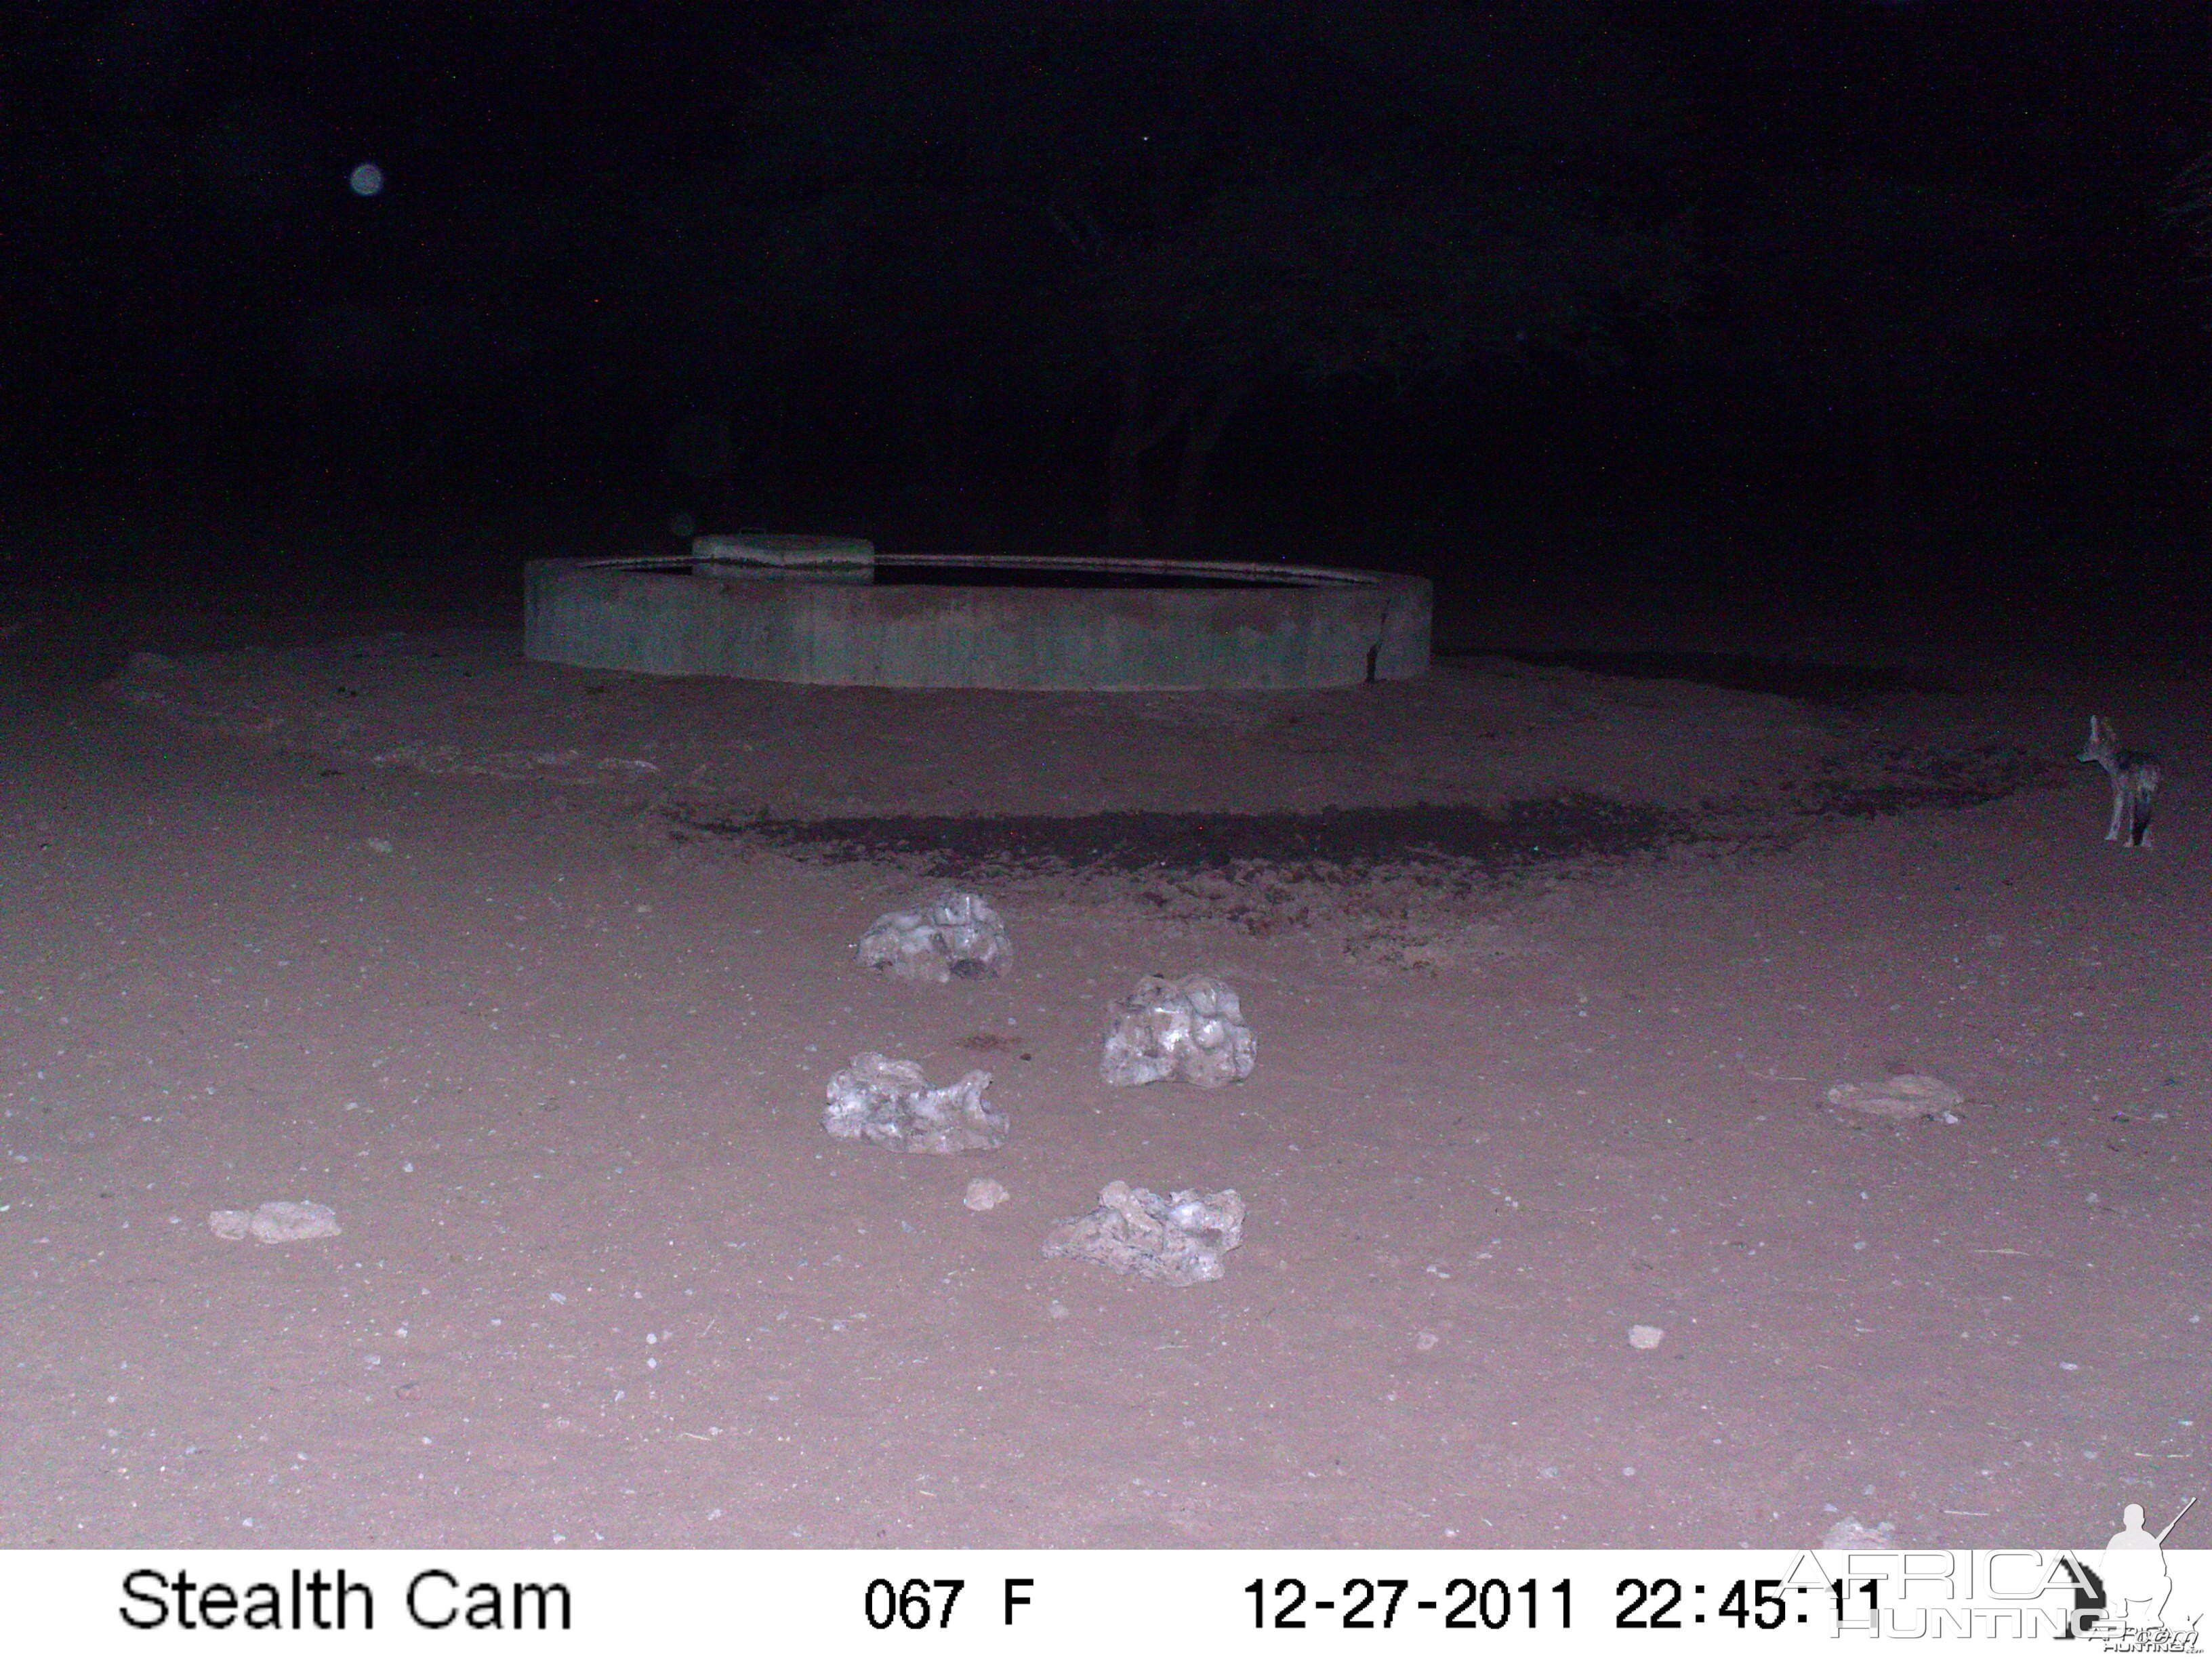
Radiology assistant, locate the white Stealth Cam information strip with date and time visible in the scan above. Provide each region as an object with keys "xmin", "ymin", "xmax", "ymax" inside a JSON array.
[{"xmin": 0, "ymin": 1533, "xmax": 2212, "ymax": 1659}]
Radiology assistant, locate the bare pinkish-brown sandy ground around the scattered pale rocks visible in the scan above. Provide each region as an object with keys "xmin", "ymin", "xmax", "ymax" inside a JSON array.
[{"xmin": 0, "ymin": 619, "xmax": 2212, "ymax": 1547}]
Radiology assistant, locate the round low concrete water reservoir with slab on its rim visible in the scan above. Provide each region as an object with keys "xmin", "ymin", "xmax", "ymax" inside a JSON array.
[{"xmin": 525, "ymin": 535, "xmax": 1431, "ymax": 690}]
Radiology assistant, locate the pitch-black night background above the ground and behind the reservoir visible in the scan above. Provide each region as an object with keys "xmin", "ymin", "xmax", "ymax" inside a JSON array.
[{"xmin": 0, "ymin": 0, "xmax": 2212, "ymax": 642}]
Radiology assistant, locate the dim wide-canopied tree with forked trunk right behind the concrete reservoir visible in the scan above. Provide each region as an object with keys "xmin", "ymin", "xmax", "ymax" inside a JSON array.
[{"xmin": 754, "ymin": 0, "xmax": 1690, "ymax": 553}]
